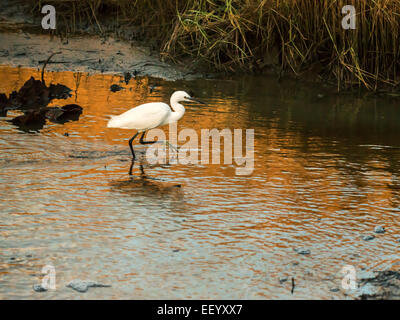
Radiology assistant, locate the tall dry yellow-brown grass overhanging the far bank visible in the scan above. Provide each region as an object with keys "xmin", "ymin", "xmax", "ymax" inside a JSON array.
[{"xmin": 27, "ymin": 0, "xmax": 400, "ymax": 90}]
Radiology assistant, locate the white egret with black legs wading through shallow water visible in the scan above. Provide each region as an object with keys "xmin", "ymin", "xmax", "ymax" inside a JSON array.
[{"xmin": 107, "ymin": 91, "xmax": 205, "ymax": 161}]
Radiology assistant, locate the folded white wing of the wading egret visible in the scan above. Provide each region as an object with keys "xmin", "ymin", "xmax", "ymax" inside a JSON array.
[{"xmin": 107, "ymin": 102, "xmax": 171, "ymax": 130}]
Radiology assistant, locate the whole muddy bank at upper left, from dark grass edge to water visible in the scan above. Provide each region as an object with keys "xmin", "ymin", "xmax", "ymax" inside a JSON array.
[{"xmin": 0, "ymin": 0, "xmax": 206, "ymax": 80}]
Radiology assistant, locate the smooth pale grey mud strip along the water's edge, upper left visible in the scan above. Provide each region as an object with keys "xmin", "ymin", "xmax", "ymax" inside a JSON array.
[{"xmin": 0, "ymin": 31, "xmax": 199, "ymax": 80}]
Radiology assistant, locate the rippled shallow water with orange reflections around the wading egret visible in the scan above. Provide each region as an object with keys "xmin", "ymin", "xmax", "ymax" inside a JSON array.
[{"xmin": 0, "ymin": 66, "xmax": 400, "ymax": 299}]
